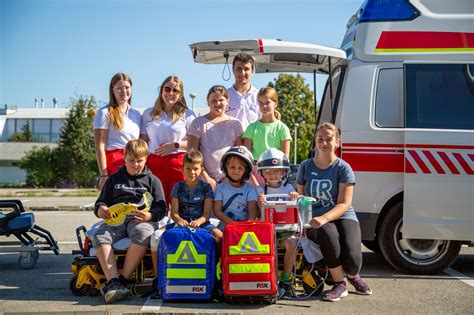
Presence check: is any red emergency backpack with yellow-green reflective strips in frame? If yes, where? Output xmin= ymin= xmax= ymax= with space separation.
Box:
xmin=222 ymin=221 xmax=277 ymax=303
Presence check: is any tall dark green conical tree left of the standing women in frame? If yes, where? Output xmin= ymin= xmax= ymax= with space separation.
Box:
xmin=58 ymin=96 xmax=97 ymax=187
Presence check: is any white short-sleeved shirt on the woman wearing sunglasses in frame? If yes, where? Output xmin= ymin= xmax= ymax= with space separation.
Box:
xmin=140 ymin=107 xmax=196 ymax=154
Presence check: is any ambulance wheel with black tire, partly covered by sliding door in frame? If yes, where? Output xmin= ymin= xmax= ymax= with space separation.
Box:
xmin=378 ymin=201 xmax=462 ymax=275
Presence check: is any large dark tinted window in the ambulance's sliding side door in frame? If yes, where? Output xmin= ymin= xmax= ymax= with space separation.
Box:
xmin=405 ymin=64 xmax=474 ymax=129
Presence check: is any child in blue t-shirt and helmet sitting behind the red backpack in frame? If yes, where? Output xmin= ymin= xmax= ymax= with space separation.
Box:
xmin=214 ymin=146 xmax=257 ymax=230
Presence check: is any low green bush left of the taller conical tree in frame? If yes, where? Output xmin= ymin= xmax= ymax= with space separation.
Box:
xmin=18 ymin=146 xmax=58 ymax=187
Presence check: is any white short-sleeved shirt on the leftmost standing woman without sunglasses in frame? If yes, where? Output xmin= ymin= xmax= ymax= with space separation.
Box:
xmin=94 ymin=105 xmax=142 ymax=151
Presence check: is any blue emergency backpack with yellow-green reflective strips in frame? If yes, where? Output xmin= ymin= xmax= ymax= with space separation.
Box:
xmin=158 ymin=227 xmax=216 ymax=300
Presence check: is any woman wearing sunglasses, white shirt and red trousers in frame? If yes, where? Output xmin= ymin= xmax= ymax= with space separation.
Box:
xmin=140 ymin=76 xmax=196 ymax=205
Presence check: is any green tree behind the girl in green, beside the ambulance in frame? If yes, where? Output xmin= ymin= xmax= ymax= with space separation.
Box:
xmin=268 ymin=74 xmax=317 ymax=163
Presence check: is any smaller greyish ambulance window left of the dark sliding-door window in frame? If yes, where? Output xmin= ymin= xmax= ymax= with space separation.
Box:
xmin=375 ymin=68 xmax=403 ymax=128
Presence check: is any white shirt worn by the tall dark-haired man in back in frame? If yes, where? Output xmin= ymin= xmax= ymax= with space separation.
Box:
xmin=225 ymin=85 xmax=260 ymax=130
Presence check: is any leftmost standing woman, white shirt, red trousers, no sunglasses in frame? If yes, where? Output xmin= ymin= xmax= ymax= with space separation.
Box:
xmin=94 ymin=73 xmax=141 ymax=189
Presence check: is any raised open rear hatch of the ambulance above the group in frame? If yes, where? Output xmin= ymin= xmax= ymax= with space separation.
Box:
xmin=189 ymin=39 xmax=347 ymax=74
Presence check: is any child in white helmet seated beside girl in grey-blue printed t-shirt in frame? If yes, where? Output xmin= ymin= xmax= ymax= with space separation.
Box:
xmin=257 ymin=148 xmax=298 ymax=299
